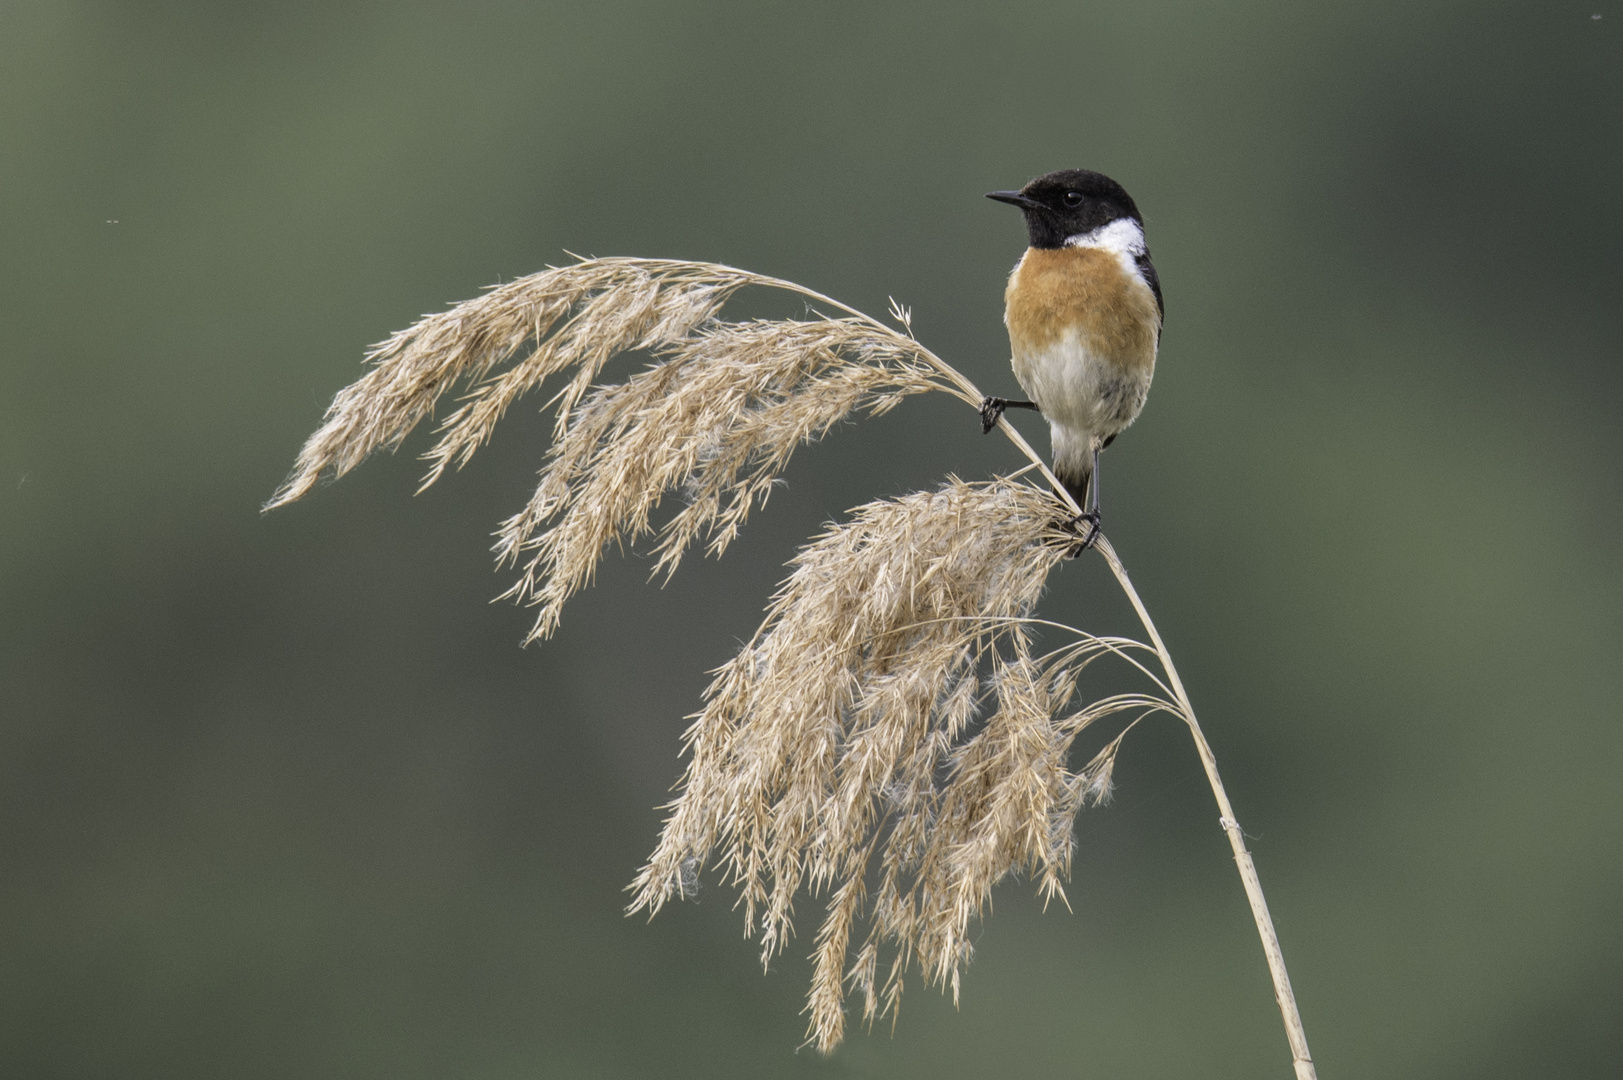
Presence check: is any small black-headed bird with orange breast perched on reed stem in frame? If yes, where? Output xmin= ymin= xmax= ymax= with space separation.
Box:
xmin=980 ymin=169 xmax=1167 ymax=554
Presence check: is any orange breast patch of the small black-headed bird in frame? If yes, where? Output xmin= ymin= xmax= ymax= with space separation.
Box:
xmin=1003 ymin=247 xmax=1160 ymax=375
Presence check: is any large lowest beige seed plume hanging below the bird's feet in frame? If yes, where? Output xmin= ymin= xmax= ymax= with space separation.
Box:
xmin=631 ymin=481 xmax=1177 ymax=1051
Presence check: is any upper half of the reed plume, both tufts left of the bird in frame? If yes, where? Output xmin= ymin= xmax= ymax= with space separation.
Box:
xmin=266 ymin=258 xmax=969 ymax=638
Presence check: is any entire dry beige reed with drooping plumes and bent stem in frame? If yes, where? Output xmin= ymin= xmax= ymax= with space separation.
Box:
xmin=266 ymin=258 xmax=1315 ymax=1080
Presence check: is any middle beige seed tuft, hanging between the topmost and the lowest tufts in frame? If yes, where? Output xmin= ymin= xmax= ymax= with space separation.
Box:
xmin=497 ymin=318 xmax=941 ymax=637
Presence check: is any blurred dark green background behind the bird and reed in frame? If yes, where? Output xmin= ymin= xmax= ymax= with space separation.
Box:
xmin=0 ymin=0 xmax=1623 ymax=1080
